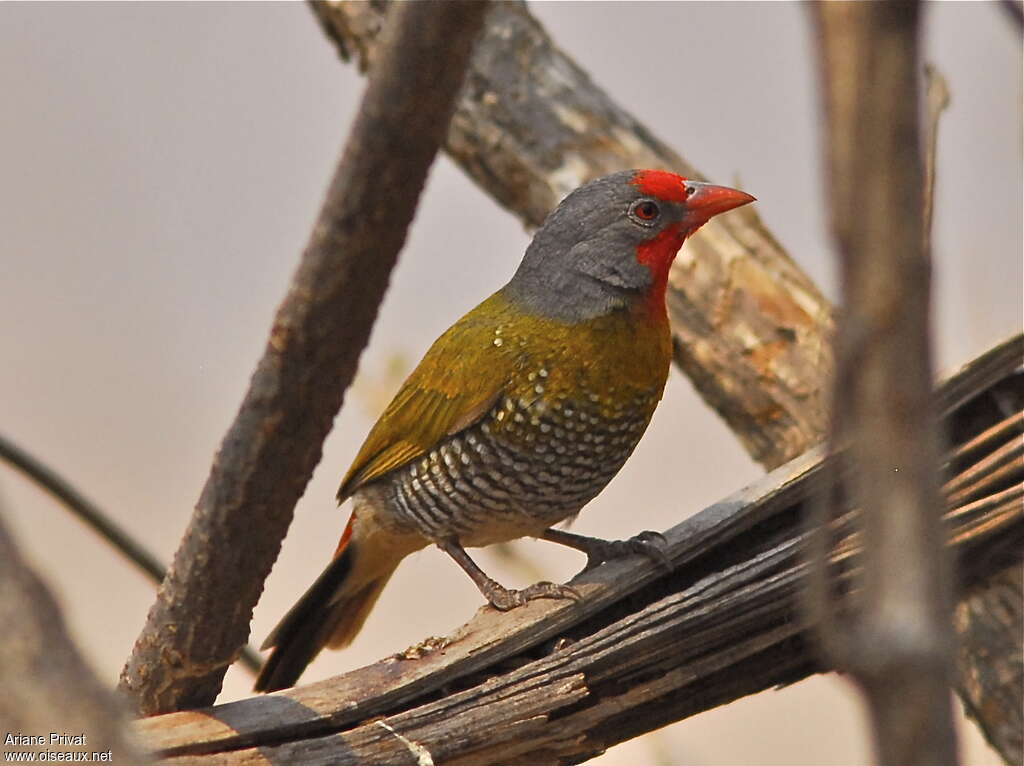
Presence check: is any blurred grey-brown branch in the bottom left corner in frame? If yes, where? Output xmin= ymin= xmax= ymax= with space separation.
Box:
xmin=0 ymin=505 xmax=147 ymax=764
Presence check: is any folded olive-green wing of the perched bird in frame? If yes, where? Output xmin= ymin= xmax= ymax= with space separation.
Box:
xmin=338 ymin=299 xmax=516 ymax=502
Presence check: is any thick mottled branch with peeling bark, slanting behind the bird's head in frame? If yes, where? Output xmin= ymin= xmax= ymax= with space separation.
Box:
xmin=312 ymin=0 xmax=831 ymax=468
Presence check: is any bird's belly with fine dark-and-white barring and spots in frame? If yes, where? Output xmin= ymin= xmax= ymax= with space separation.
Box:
xmin=372 ymin=367 xmax=662 ymax=546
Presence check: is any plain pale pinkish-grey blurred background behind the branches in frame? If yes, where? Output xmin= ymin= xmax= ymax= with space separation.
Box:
xmin=0 ymin=2 xmax=1022 ymax=766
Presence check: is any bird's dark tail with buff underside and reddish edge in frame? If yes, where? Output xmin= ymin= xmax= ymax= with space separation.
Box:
xmin=254 ymin=513 xmax=408 ymax=691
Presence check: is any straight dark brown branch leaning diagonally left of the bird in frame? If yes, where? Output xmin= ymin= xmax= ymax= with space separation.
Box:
xmin=121 ymin=2 xmax=486 ymax=713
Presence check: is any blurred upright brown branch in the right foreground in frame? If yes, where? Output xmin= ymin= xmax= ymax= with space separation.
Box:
xmin=815 ymin=2 xmax=957 ymax=766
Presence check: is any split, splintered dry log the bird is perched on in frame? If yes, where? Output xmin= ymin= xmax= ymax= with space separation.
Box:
xmin=137 ymin=337 xmax=1024 ymax=766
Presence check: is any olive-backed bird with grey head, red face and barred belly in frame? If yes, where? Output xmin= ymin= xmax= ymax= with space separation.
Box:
xmin=255 ymin=169 xmax=755 ymax=691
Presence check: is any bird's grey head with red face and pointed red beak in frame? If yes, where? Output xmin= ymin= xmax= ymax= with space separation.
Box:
xmin=504 ymin=170 xmax=754 ymax=323
